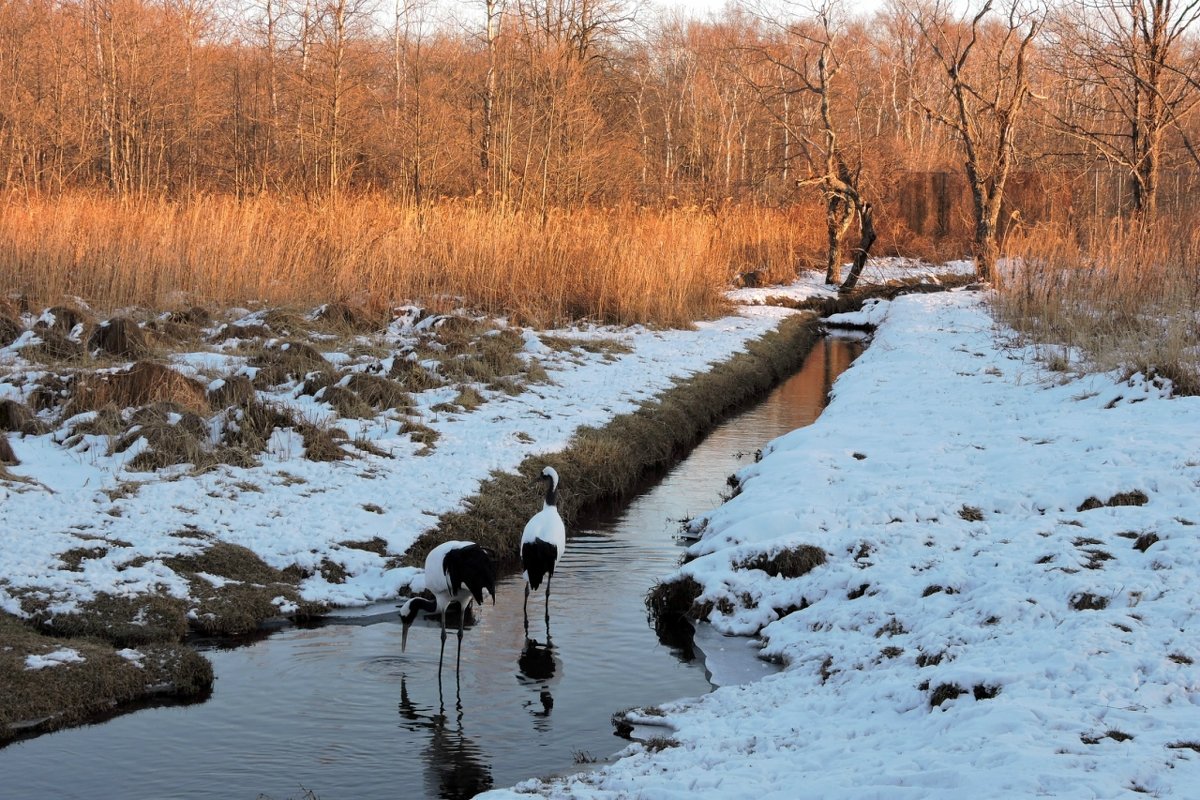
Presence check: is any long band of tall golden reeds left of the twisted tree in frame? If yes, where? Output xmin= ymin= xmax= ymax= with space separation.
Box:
xmin=0 ymin=194 xmax=820 ymax=330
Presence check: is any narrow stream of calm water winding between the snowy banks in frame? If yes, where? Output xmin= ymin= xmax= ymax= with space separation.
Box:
xmin=0 ymin=338 xmax=862 ymax=800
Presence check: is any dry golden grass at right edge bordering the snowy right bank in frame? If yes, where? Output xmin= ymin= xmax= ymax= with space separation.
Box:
xmin=998 ymin=221 xmax=1200 ymax=395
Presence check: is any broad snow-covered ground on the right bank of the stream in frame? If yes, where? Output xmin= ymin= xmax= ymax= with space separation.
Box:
xmin=484 ymin=286 xmax=1200 ymax=800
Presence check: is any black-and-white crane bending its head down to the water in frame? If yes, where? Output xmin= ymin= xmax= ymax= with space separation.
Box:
xmin=400 ymin=542 xmax=496 ymax=673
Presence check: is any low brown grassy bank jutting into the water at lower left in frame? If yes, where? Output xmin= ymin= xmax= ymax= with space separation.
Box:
xmin=0 ymin=614 xmax=212 ymax=742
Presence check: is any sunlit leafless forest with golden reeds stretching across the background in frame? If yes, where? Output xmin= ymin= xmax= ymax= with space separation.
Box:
xmin=0 ymin=0 xmax=1200 ymax=338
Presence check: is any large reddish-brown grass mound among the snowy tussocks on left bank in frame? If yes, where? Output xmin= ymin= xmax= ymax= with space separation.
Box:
xmin=67 ymin=361 xmax=210 ymax=414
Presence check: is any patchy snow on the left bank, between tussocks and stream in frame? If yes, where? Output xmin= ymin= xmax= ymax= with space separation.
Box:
xmin=0 ymin=298 xmax=794 ymax=614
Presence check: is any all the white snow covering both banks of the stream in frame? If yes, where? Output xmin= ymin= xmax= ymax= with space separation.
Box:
xmin=0 ymin=265 xmax=1200 ymax=800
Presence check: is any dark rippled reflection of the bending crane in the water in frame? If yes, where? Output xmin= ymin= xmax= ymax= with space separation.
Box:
xmin=400 ymin=675 xmax=492 ymax=800
